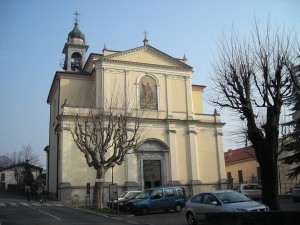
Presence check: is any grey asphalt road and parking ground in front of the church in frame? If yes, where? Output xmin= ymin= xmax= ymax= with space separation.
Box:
xmin=0 ymin=192 xmax=300 ymax=225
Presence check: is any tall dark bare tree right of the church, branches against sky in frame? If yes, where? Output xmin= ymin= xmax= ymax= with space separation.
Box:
xmin=211 ymin=21 xmax=299 ymax=209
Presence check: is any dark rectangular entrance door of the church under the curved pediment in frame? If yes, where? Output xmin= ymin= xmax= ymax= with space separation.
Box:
xmin=143 ymin=160 xmax=161 ymax=189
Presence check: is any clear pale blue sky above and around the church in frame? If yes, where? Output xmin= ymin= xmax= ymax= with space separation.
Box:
xmin=0 ymin=0 xmax=300 ymax=167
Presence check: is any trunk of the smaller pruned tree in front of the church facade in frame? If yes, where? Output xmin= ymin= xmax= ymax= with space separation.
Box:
xmin=93 ymin=167 xmax=105 ymax=209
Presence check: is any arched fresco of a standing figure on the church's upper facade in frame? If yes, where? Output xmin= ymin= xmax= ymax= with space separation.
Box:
xmin=140 ymin=76 xmax=158 ymax=110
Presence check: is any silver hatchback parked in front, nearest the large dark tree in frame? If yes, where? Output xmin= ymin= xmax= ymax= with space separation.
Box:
xmin=186 ymin=191 xmax=269 ymax=225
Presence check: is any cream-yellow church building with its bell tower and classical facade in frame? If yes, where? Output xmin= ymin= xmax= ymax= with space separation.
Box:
xmin=46 ymin=16 xmax=227 ymax=201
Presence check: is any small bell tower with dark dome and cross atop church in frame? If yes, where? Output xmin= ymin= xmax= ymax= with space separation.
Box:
xmin=61 ymin=11 xmax=89 ymax=71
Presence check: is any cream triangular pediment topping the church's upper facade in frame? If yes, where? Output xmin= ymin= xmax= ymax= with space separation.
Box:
xmin=102 ymin=45 xmax=192 ymax=70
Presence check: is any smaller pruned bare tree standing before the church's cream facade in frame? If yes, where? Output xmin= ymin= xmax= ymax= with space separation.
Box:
xmin=70 ymin=90 xmax=143 ymax=208
